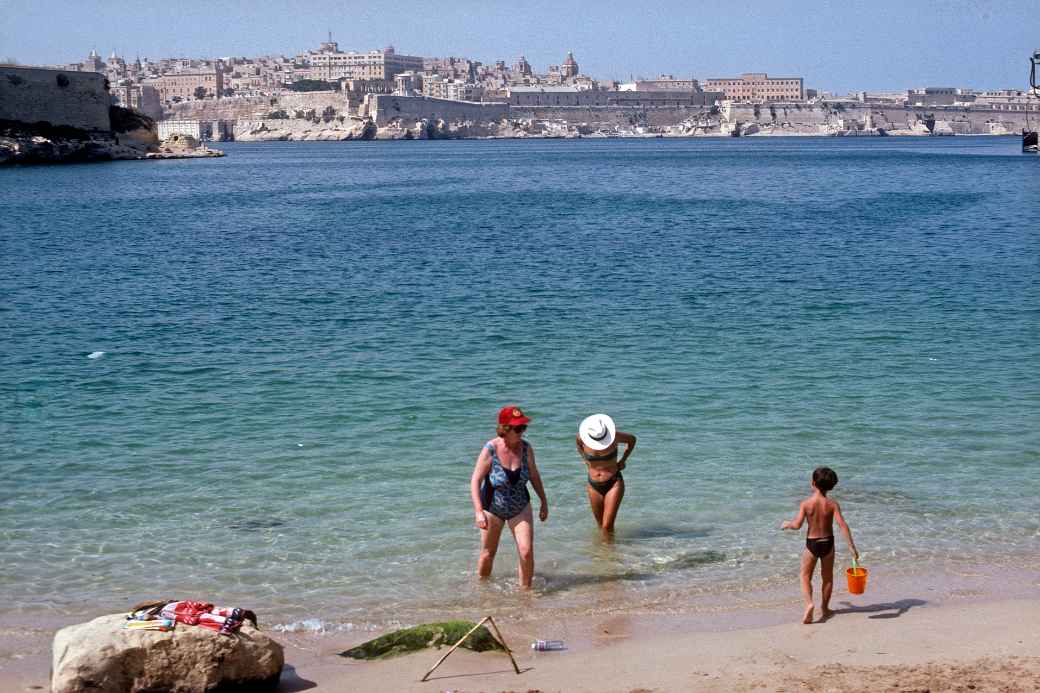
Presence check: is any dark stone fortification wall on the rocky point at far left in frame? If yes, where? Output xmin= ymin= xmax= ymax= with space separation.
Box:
xmin=0 ymin=66 xmax=111 ymax=130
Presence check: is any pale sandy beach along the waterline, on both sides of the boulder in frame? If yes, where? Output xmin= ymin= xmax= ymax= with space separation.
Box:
xmin=0 ymin=573 xmax=1040 ymax=693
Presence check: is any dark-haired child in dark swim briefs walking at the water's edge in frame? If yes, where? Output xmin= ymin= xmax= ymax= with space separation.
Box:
xmin=780 ymin=467 xmax=859 ymax=623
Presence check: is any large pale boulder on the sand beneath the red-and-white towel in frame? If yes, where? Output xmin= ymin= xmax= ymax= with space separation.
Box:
xmin=51 ymin=614 xmax=285 ymax=693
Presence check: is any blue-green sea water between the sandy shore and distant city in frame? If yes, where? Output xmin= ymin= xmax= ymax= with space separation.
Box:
xmin=0 ymin=137 xmax=1040 ymax=626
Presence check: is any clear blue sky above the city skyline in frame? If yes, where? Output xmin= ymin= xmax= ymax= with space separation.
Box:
xmin=0 ymin=0 xmax=1040 ymax=94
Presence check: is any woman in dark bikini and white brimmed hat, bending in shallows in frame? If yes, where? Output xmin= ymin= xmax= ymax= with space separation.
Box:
xmin=575 ymin=414 xmax=635 ymax=534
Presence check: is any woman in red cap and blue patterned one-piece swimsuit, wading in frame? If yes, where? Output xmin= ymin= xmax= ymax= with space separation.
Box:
xmin=469 ymin=405 xmax=549 ymax=589
